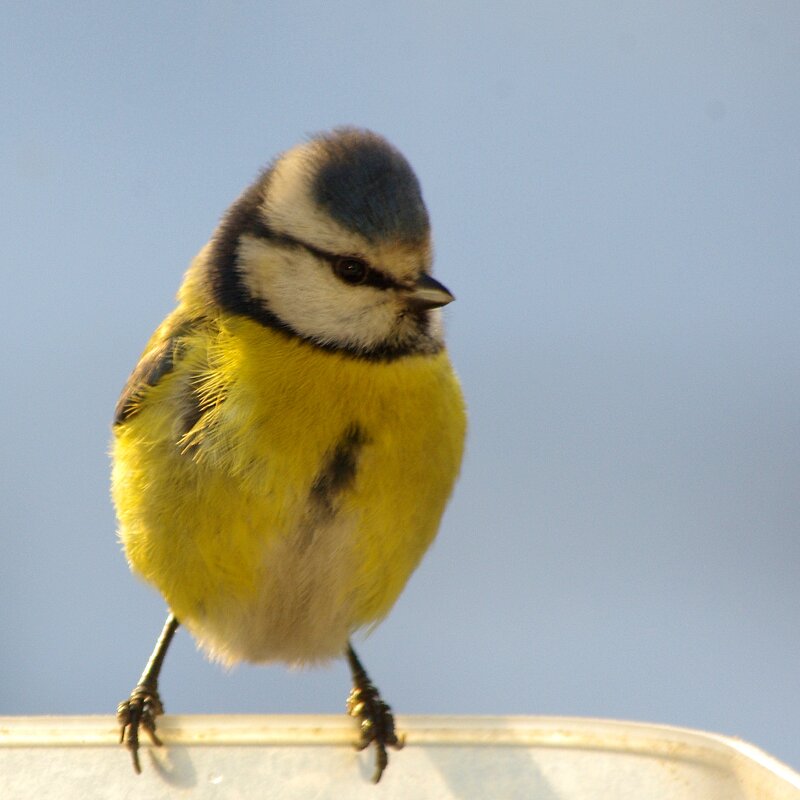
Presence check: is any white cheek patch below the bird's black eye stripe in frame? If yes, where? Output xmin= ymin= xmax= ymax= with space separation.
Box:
xmin=239 ymin=237 xmax=401 ymax=348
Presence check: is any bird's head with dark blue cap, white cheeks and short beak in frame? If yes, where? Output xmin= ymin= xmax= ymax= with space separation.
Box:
xmin=207 ymin=128 xmax=453 ymax=358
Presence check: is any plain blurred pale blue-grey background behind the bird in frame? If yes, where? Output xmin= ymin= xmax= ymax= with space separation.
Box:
xmin=0 ymin=0 xmax=800 ymax=768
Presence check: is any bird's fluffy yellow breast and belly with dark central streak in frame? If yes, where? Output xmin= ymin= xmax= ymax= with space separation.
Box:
xmin=113 ymin=317 xmax=465 ymax=661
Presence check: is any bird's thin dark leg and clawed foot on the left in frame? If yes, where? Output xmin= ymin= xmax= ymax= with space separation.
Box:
xmin=117 ymin=613 xmax=180 ymax=774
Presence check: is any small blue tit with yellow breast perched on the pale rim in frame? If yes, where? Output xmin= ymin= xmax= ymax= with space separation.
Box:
xmin=111 ymin=127 xmax=467 ymax=782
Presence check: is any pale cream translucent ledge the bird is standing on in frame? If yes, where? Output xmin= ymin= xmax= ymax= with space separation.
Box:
xmin=0 ymin=715 xmax=800 ymax=800
